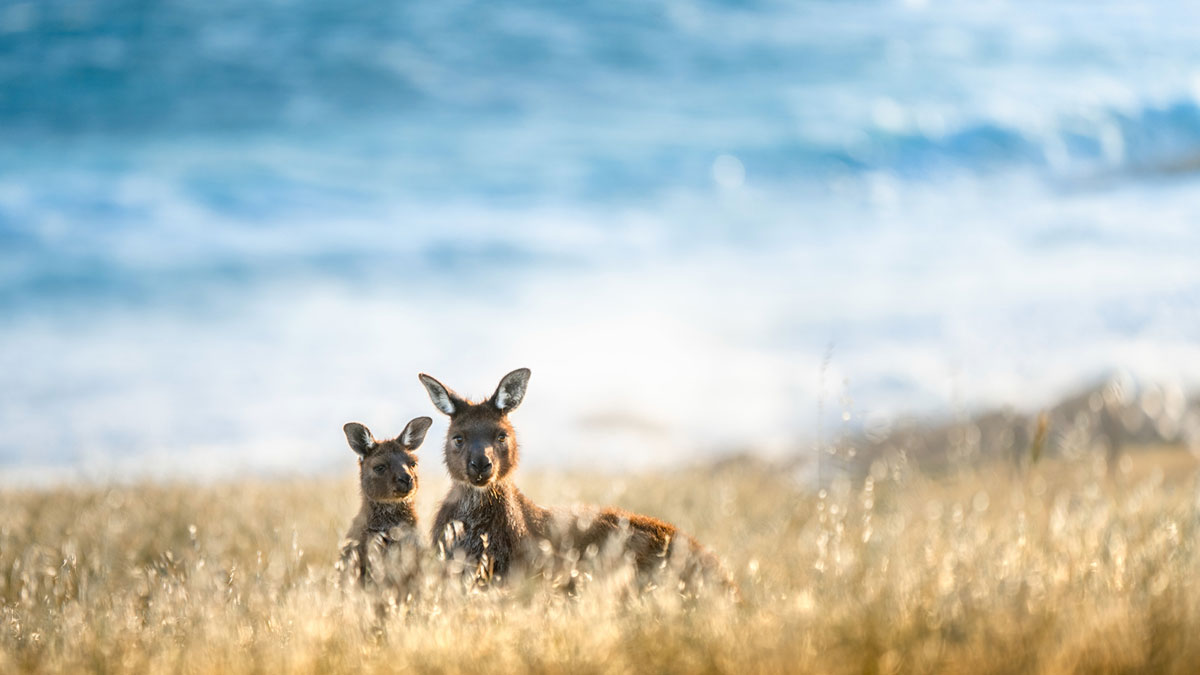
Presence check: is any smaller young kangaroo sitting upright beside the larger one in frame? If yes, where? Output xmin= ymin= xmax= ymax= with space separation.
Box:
xmin=338 ymin=417 xmax=433 ymax=583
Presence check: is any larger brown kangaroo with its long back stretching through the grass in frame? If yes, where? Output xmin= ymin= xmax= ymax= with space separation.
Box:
xmin=420 ymin=368 xmax=737 ymax=597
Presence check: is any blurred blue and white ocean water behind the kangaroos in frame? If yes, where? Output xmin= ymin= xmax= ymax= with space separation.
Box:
xmin=0 ymin=0 xmax=1200 ymax=479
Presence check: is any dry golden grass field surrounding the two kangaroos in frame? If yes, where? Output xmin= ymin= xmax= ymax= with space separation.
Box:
xmin=0 ymin=450 xmax=1200 ymax=674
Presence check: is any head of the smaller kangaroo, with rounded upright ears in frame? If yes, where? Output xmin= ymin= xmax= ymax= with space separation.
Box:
xmin=342 ymin=417 xmax=433 ymax=503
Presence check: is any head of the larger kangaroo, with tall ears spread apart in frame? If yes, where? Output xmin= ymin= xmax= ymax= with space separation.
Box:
xmin=420 ymin=368 xmax=529 ymax=488
